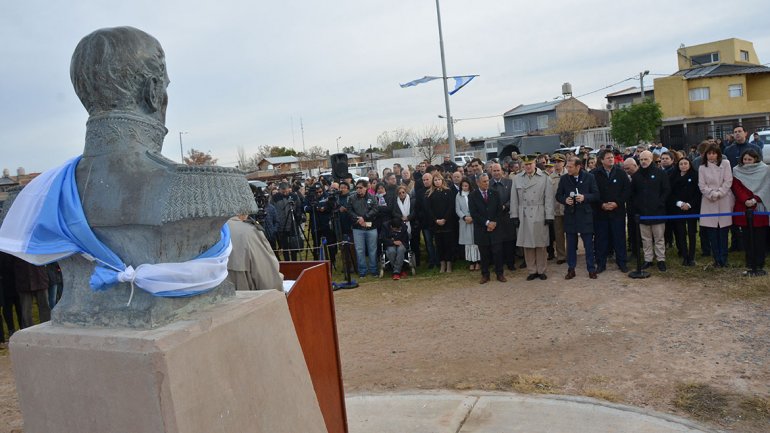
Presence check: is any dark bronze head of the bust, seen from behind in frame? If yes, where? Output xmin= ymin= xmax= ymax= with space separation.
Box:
xmin=70 ymin=27 xmax=170 ymax=123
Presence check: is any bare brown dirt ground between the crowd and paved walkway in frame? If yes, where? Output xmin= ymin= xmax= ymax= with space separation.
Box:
xmin=0 ymin=257 xmax=770 ymax=433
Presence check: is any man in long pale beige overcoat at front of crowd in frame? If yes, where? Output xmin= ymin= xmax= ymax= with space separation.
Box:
xmin=511 ymin=155 xmax=555 ymax=281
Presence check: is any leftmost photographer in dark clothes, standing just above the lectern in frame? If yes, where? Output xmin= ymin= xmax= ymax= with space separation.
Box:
xmin=273 ymin=182 xmax=304 ymax=261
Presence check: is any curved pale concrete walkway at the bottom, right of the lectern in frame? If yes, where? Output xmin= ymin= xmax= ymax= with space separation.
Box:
xmin=346 ymin=392 xmax=717 ymax=433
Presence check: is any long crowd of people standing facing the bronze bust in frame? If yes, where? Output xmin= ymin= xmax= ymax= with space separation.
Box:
xmin=264 ymin=125 xmax=770 ymax=284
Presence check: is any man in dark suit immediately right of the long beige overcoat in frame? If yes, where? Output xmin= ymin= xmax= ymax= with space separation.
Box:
xmin=556 ymin=156 xmax=600 ymax=280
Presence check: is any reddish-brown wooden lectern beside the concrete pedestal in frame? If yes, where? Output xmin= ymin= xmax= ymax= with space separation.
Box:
xmin=280 ymin=262 xmax=348 ymax=433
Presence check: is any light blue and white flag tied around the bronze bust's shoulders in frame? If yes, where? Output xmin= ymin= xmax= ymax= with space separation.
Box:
xmin=0 ymin=156 xmax=232 ymax=297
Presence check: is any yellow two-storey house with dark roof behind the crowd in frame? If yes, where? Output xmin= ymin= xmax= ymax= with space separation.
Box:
xmin=654 ymin=38 xmax=770 ymax=149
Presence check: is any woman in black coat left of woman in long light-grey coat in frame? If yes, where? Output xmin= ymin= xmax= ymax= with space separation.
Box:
xmin=425 ymin=173 xmax=457 ymax=272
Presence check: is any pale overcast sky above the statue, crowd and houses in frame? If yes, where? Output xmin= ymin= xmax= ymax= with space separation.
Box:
xmin=0 ymin=0 xmax=770 ymax=174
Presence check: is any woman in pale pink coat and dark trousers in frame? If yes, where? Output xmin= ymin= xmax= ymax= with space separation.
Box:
xmin=698 ymin=144 xmax=735 ymax=268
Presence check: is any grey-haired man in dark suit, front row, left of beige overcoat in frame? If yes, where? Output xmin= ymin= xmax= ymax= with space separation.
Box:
xmin=468 ymin=173 xmax=508 ymax=284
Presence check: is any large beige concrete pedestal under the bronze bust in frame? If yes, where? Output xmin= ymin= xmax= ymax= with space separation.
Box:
xmin=10 ymin=291 xmax=326 ymax=433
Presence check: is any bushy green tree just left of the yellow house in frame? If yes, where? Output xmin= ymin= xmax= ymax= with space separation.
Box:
xmin=611 ymin=99 xmax=663 ymax=146
